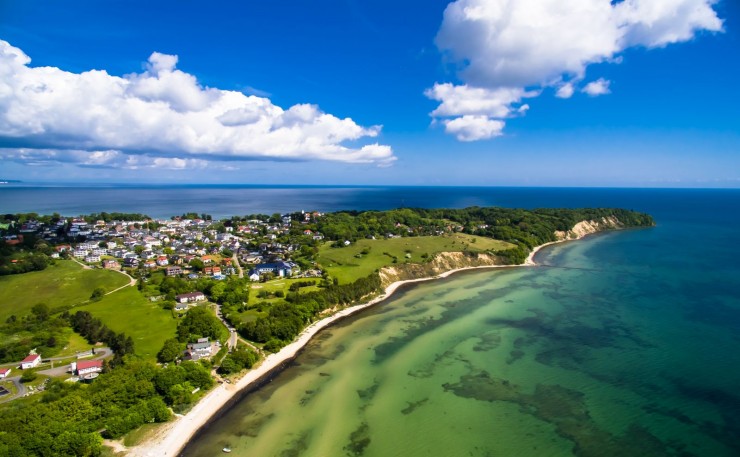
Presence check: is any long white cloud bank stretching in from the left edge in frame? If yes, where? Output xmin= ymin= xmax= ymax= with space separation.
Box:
xmin=0 ymin=40 xmax=395 ymax=169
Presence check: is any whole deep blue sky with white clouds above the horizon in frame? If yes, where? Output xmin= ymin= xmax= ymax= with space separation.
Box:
xmin=0 ymin=0 xmax=740 ymax=187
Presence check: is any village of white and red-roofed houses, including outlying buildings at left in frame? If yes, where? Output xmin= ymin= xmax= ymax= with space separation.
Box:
xmin=0 ymin=212 xmax=330 ymax=401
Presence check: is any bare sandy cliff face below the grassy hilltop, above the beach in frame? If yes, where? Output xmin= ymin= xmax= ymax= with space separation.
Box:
xmin=379 ymin=252 xmax=503 ymax=287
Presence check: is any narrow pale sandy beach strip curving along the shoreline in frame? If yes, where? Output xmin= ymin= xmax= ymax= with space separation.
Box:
xmin=129 ymin=236 xmax=572 ymax=457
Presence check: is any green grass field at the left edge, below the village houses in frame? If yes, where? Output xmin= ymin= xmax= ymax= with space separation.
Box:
xmin=0 ymin=260 xmax=129 ymax=322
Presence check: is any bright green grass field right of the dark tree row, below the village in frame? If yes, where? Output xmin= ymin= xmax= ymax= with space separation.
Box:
xmin=75 ymin=287 xmax=177 ymax=360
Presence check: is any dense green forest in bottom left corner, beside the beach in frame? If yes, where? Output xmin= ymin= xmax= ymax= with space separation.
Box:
xmin=0 ymin=357 xmax=213 ymax=457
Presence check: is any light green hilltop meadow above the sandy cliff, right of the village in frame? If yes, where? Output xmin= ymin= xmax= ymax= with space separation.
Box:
xmin=318 ymin=233 xmax=514 ymax=284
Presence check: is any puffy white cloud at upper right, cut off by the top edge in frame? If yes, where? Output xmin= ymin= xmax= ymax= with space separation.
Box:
xmin=425 ymin=0 xmax=722 ymax=141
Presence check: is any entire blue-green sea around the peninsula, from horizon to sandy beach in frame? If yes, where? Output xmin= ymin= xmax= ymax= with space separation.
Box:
xmin=0 ymin=186 xmax=740 ymax=457
